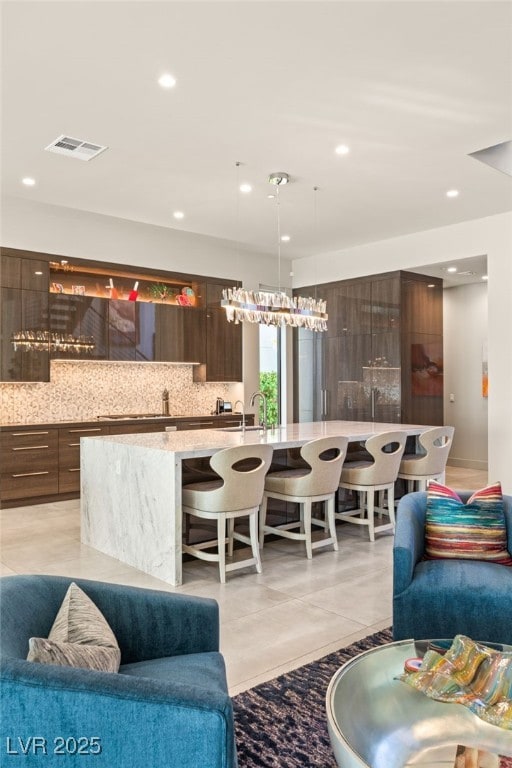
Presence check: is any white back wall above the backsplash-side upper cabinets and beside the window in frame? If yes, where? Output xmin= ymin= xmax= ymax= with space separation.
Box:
xmin=1 ymin=197 xmax=291 ymax=397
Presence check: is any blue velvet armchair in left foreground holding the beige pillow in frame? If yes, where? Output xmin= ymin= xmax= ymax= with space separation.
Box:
xmin=0 ymin=576 xmax=237 ymax=768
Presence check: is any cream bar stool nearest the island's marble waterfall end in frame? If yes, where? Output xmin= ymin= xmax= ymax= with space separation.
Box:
xmin=182 ymin=445 xmax=272 ymax=584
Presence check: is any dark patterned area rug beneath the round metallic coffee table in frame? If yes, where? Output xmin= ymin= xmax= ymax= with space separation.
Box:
xmin=233 ymin=629 xmax=393 ymax=768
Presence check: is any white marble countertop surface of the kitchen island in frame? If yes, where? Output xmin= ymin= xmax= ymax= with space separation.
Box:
xmin=83 ymin=421 xmax=427 ymax=459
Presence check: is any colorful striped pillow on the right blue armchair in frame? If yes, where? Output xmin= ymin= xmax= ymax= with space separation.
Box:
xmin=425 ymin=481 xmax=512 ymax=566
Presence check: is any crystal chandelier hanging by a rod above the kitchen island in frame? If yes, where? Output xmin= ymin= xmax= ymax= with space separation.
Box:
xmin=221 ymin=171 xmax=328 ymax=331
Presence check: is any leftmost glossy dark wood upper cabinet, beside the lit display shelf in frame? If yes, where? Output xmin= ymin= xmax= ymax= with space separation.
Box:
xmin=0 ymin=254 xmax=50 ymax=381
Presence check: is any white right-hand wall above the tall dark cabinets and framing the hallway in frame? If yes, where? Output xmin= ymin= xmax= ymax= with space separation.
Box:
xmin=292 ymin=212 xmax=512 ymax=494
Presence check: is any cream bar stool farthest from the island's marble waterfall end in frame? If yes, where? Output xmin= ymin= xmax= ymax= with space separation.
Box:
xmin=398 ymin=427 xmax=455 ymax=493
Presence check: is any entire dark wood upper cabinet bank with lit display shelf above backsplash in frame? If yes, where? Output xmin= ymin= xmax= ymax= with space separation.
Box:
xmin=0 ymin=248 xmax=242 ymax=382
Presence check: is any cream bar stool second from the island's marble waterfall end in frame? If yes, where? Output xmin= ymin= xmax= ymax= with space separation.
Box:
xmin=260 ymin=437 xmax=348 ymax=560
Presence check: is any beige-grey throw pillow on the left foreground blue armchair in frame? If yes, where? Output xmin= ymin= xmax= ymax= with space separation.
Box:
xmin=27 ymin=582 xmax=121 ymax=672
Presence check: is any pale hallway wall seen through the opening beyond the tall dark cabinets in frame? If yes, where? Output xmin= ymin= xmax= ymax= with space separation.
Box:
xmin=443 ymin=283 xmax=488 ymax=468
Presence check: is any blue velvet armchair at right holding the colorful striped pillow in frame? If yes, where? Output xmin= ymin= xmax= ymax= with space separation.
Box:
xmin=393 ymin=491 xmax=512 ymax=645
